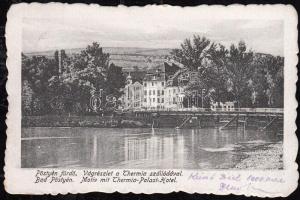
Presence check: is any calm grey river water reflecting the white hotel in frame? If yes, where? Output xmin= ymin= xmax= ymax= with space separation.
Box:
xmin=21 ymin=127 xmax=282 ymax=169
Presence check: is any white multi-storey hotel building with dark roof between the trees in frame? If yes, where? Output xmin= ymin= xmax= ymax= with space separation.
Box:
xmin=121 ymin=64 xmax=184 ymax=110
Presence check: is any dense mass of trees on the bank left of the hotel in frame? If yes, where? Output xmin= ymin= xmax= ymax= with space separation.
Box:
xmin=22 ymin=43 xmax=125 ymax=115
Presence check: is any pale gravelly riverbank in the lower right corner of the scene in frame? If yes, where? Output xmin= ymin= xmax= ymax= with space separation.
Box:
xmin=234 ymin=142 xmax=283 ymax=170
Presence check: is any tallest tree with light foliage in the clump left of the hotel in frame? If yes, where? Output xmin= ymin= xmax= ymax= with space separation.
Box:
xmin=50 ymin=42 xmax=109 ymax=113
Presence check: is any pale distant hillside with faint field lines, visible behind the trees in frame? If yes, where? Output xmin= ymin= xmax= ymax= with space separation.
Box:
xmin=24 ymin=47 xmax=171 ymax=71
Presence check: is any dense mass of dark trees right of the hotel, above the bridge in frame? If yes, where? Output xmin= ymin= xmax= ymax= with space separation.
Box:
xmin=171 ymin=36 xmax=284 ymax=107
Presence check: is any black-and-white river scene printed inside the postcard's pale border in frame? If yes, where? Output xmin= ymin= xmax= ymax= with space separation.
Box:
xmin=21 ymin=9 xmax=285 ymax=170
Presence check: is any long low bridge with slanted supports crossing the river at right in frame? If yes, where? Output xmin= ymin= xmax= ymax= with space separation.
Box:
xmin=133 ymin=108 xmax=284 ymax=130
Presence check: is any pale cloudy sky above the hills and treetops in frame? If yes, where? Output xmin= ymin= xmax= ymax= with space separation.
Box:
xmin=22 ymin=13 xmax=284 ymax=56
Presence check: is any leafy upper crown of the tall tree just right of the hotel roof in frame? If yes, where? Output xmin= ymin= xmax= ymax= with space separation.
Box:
xmin=171 ymin=35 xmax=210 ymax=73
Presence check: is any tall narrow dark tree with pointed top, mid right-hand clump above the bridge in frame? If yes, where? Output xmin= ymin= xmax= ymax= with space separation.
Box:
xmin=226 ymin=41 xmax=254 ymax=107
